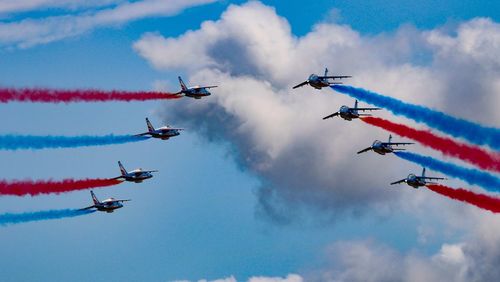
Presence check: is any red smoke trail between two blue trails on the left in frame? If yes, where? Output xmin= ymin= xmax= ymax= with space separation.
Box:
xmin=0 ymin=179 xmax=121 ymax=196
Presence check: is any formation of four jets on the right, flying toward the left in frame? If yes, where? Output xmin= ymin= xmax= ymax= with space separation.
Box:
xmin=292 ymin=68 xmax=445 ymax=188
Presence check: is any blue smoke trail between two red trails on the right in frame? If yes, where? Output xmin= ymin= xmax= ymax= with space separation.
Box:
xmin=394 ymin=152 xmax=500 ymax=189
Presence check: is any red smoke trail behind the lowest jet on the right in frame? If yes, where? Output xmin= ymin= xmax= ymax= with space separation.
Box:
xmin=427 ymin=185 xmax=500 ymax=213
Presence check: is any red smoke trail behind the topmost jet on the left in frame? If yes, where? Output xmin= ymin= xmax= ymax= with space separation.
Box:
xmin=0 ymin=88 xmax=181 ymax=103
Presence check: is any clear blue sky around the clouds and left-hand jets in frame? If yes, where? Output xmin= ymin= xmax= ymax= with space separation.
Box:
xmin=0 ymin=0 xmax=500 ymax=281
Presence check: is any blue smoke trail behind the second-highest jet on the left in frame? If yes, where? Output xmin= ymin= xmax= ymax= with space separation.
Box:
xmin=0 ymin=134 xmax=149 ymax=150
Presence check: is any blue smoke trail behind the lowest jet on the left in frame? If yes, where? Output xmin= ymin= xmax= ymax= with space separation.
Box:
xmin=0 ymin=209 xmax=95 ymax=226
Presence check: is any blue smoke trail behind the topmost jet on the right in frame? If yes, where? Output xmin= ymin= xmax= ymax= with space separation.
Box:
xmin=331 ymin=85 xmax=500 ymax=150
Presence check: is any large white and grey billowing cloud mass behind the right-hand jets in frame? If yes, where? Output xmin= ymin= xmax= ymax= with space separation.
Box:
xmin=134 ymin=2 xmax=500 ymax=281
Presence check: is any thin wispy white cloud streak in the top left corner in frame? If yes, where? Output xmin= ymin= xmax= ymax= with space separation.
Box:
xmin=0 ymin=0 xmax=215 ymax=48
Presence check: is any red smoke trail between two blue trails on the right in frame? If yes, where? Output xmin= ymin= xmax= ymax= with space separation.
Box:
xmin=361 ymin=117 xmax=500 ymax=172
